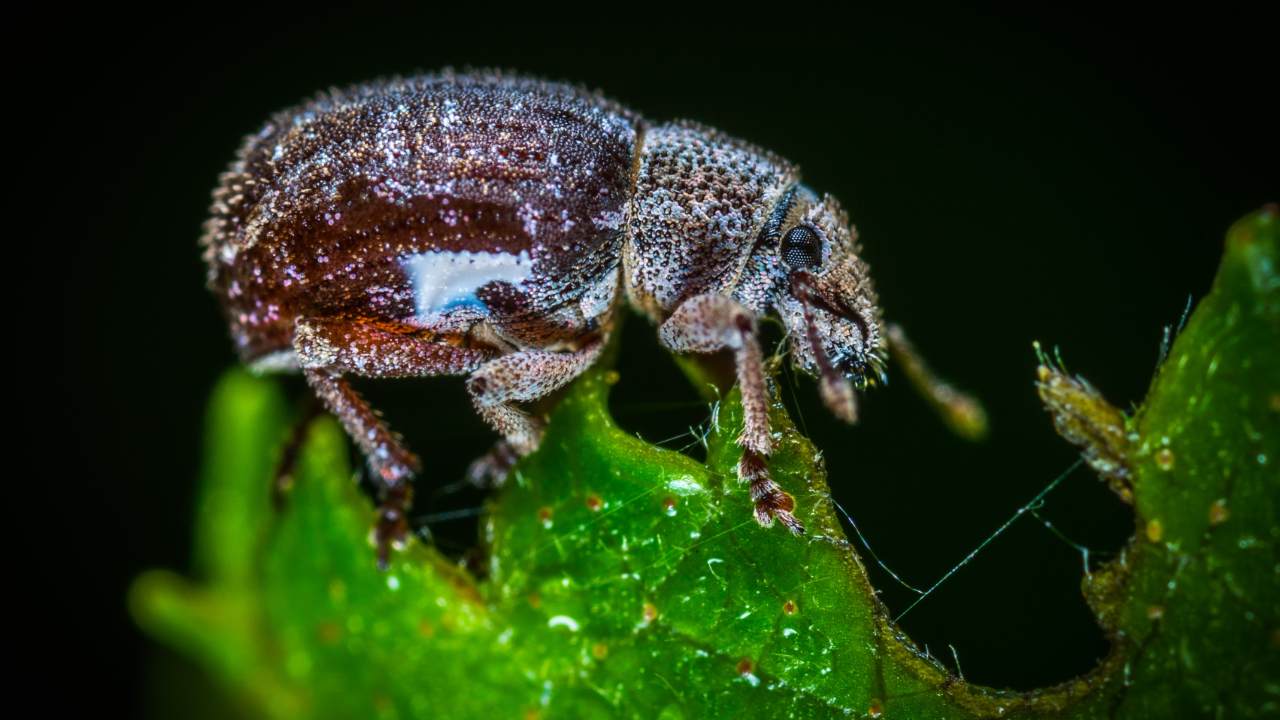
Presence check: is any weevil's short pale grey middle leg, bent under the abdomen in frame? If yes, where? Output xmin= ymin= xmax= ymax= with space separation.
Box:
xmin=467 ymin=334 xmax=605 ymax=461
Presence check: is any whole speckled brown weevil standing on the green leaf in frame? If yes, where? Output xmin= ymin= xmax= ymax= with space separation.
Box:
xmin=202 ymin=72 xmax=977 ymax=566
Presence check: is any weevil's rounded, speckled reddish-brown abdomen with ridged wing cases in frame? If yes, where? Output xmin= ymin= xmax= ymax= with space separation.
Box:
xmin=205 ymin=74 xmax=639 ymax=359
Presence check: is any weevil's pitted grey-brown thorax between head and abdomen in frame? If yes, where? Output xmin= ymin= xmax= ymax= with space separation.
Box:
xmin=623 ymin=122 xmax=797 ymax=320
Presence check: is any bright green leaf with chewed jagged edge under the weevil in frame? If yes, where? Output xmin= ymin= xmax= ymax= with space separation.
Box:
xmin=131 ymin=209 xmax=1280 ymax=719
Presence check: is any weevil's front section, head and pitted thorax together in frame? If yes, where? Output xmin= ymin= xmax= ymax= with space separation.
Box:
xmin=623 ymin=123 xmax=884 ymax=421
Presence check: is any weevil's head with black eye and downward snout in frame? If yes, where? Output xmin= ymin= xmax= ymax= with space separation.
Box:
xmin=765 ymin=186 xmax=884 ymax=423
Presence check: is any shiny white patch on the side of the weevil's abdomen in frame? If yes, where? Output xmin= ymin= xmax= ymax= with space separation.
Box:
xmin=401 ymin=250 xmax=532 ymax=319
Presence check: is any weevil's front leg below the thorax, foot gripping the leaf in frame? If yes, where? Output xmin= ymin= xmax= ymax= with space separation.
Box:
xmin=658 ymin=295 xmax=804 ymax=534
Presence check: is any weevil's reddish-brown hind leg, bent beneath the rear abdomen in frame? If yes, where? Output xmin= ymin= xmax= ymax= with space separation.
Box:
xmin=293 ymin=318 xmax=494 ymax=568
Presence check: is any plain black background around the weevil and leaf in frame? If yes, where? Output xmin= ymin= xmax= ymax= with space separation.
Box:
xmin=57 ymin=8 xmax=1280 ymax=712
